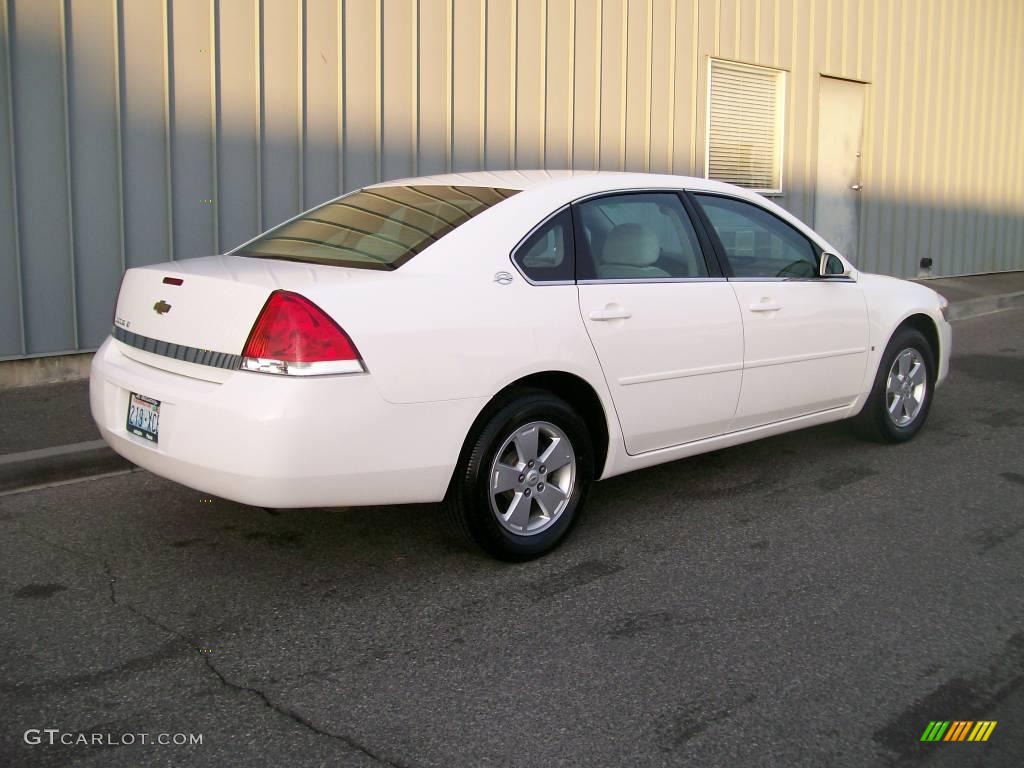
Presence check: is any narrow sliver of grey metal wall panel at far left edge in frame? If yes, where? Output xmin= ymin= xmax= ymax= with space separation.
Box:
xmin=0 ymin=1 xmax=26 ymax=357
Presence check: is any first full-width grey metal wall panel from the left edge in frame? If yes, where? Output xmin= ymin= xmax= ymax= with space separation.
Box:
xmin=10 ymin=0 xmax=78 ymax=353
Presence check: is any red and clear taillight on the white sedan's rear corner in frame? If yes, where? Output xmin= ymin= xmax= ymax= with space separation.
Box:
xmin=242 ymin=291 xmax=366 ymax=376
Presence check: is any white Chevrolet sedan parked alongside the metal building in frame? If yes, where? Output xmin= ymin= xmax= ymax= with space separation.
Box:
xmin=90 ymin=171 xmax=951 ymax=559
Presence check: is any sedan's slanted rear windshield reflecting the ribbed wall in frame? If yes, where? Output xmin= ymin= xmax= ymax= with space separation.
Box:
xmin=233 ymin=185 xmax=518 ymax=269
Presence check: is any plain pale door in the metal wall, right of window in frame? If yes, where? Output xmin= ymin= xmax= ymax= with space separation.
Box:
xmin=814 ymin=77 xmax=864 ymax=260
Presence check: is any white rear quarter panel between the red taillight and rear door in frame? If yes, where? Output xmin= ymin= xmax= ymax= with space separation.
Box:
xmin=292 ymin=186 xmax=614 ymax=402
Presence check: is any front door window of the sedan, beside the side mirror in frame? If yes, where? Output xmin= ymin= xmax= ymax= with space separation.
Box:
xmin=693 ymin=195 xmax=818 ymax=280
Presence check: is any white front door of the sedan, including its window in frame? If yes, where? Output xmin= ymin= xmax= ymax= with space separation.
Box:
xmin=690 ymin=193 xmax=868 ymax=431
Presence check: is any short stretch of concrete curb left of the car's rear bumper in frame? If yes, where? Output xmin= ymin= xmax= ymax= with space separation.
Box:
xmin=0 ymin=440 xmax=132 ymax=494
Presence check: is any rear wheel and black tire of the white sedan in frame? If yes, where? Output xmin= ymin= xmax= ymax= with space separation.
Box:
xmin=443 ymin=389 xmax=594 ymax=561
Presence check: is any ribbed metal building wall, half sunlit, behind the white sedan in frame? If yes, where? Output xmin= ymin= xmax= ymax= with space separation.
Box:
xmin=0 ymin=0 xmax=1024 ymax=358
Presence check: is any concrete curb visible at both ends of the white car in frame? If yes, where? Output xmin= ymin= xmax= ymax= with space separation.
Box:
xmin=0 ymin=291 xmax=1024 ymax=494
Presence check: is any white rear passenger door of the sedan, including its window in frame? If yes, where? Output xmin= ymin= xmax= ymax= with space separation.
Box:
xmin=572 ymin=190 xmax=743 ymax=455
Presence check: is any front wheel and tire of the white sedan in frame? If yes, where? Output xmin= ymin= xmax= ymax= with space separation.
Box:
xmin=855 ymin=328 xmax=937 ymax=443
